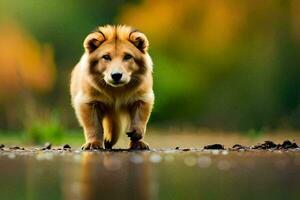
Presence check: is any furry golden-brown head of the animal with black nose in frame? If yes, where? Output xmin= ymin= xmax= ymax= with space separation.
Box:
xmin=83 ymin=25 xmax=152 ymax=87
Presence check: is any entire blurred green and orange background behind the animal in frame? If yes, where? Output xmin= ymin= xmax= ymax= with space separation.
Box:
xmin=0 ymin=0 xmax=300 ymax=143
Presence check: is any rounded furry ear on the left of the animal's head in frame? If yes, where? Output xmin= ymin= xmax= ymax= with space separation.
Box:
xmin=83 ymin=31 xmax=105 ymax=53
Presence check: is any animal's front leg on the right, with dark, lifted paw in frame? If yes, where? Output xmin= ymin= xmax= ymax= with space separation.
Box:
xmin=127 ymin=101 xmax=152 ymax=150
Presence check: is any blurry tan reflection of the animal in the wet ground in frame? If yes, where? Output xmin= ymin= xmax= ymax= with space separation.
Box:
xmin=64 ymin=152 xmax=151 ymax=200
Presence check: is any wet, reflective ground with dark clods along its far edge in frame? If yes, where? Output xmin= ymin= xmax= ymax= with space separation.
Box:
xmin=0 ymin=141 xmax=300 ymax=200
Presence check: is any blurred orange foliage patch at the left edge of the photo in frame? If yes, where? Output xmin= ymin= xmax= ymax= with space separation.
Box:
xmin=0 ymin=21 xmax=55 ymax=103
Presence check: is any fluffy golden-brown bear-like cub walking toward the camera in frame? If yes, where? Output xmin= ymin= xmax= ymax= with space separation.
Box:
xmin=70 ymin=25 xmax=154 ymax=150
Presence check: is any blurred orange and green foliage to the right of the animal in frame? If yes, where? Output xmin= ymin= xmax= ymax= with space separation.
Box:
xmin=118 ymin=0 xmax=300 ymax=129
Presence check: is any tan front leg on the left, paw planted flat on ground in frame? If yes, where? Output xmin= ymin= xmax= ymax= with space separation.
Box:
xmin=75 ymin=103 xmax=103 ymax=150
